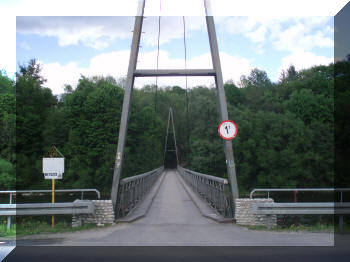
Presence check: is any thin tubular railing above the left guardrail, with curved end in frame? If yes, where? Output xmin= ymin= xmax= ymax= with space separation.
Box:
xmin=0 ymin=188 xmax=101 ymax=229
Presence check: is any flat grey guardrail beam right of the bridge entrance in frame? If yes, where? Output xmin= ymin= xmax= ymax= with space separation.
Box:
xmin=253 ymin=202 xmax=350 ymax=215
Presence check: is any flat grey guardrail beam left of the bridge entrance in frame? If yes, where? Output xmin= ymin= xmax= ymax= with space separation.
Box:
xmin=0 ymin=200 xmax=94 ymax=216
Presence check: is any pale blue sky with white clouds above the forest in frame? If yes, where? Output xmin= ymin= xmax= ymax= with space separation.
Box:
xmin=0 ymin=0 xmax=344 ymax=94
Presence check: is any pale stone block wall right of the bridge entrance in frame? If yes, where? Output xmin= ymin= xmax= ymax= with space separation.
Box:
xmin=235 ymin=198 xmax=277 ymax=228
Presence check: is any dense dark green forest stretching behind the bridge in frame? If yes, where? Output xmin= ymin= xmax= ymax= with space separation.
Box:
xmin=0 ymin=60 xmax=350 ymax=193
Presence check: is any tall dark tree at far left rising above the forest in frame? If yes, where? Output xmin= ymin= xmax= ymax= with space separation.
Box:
xmin=16 ymin=60 xmax=57 ymax=188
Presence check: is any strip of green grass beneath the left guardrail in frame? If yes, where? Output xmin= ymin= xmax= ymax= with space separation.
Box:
xmin=0 ymin=221 xmax=112 ymax=238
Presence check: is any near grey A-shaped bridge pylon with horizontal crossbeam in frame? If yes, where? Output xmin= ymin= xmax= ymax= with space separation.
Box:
xmin=111 ymin=0 xmax=238 ymax=213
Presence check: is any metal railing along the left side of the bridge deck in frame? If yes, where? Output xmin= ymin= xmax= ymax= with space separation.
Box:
xmin=115 ymin=166 xmax=164 ymax=218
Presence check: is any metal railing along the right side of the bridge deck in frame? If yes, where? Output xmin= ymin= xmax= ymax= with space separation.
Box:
xmin=177 ymin=166 xmax=234 ymax=217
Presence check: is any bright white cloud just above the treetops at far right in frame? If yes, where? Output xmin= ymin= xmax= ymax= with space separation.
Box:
xmin=278 ymin=51 xmax=333 ymax=75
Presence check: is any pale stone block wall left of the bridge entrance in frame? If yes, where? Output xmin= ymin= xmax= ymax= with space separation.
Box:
xmin=72 ymin=200 xmax=114 ymax=227
